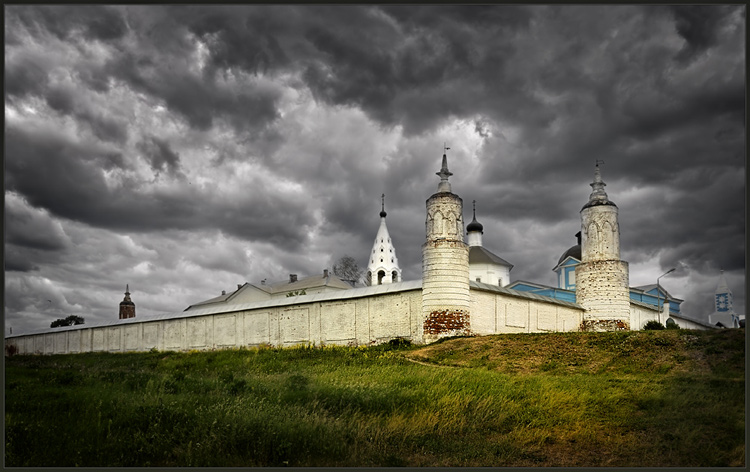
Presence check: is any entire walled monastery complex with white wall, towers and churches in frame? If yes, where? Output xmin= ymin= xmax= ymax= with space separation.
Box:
xmin=5 ymin=154 xmax=734 ymax=354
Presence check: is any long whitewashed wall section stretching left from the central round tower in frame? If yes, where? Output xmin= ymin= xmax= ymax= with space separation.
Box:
xmin=6 ymin=281 xmax=422 ymax=354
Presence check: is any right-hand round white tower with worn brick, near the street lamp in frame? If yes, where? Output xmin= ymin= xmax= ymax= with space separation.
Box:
xmin=575 ymin=161 xmax=630 ymax=331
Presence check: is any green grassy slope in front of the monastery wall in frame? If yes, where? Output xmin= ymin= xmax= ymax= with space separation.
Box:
xmin=5 ymin=330 xmax=745 ymax=467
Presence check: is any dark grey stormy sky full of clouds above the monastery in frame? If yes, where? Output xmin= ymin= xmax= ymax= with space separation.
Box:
xmin=4 ymin=5 xmax=746 ymax=333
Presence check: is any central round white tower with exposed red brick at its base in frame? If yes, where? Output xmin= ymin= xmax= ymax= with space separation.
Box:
xmin=422 ymin=148 xmax=470 ymax=342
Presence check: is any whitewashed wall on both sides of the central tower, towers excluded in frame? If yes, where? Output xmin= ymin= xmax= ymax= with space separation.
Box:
xmin=5 ymin=281 xmax=583 ymax=354
